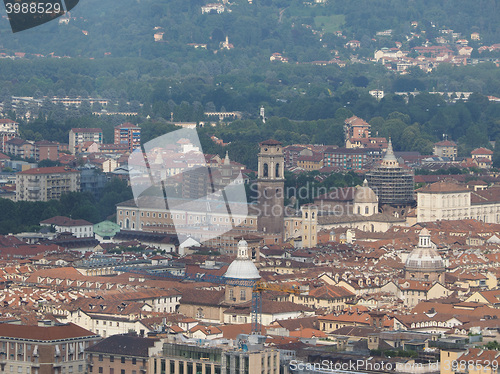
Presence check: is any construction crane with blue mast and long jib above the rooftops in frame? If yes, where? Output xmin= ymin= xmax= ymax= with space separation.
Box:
xmin=115 ymin=267 xmax=301 ymax=335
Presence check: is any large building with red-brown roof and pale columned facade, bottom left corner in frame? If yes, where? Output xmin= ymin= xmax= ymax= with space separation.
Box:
xmin=0 ymin=322 xmax=101 ymax=374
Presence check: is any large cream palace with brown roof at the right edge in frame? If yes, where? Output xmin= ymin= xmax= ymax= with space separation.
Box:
xmin=417 ymin=180 xmax=500 ymax=223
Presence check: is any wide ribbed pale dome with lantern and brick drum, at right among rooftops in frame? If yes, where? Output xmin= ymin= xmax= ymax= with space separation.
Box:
xmin=405 ymin=228 xmax=445 ymax=284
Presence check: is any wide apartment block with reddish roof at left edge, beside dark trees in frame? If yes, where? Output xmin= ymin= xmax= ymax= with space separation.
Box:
xmin=16 ymin=166 xmax=80 ymax=201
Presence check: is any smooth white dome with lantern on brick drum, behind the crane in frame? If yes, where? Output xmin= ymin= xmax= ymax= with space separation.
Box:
xmin=224 ymin=239 xmax=260 ymax=305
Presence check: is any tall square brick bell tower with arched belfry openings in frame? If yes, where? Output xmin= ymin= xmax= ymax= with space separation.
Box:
xmin=257 ymin=139 xmax=285 ymax=234
